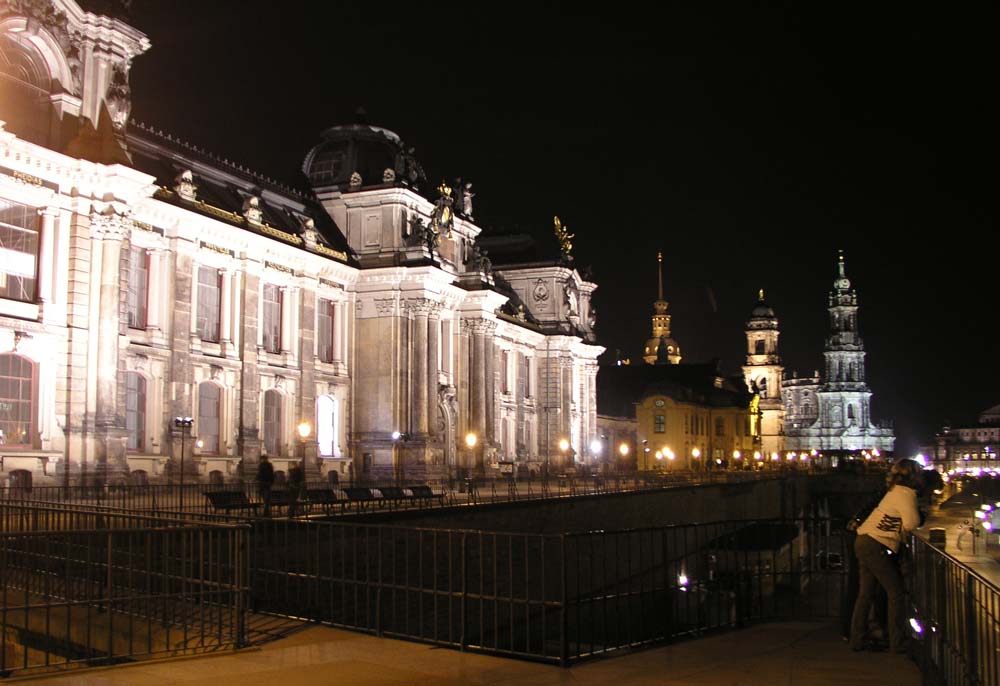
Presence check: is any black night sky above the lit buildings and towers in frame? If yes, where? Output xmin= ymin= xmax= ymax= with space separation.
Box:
xmin=131 ymin=5 xmax=1000 ymax=452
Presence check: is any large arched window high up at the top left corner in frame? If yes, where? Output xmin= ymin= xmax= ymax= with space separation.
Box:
xmin=0 ymin=32 xmax=52 ymax=145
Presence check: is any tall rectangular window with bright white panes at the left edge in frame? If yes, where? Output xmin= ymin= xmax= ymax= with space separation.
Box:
xmin=0 ymin=198 xmax=38 ymax=302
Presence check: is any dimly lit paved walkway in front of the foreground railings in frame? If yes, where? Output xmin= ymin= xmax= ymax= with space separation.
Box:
xmin=12 ymin=622 xmax=920 ymax=686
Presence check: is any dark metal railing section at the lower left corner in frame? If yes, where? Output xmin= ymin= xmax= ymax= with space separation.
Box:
xmin=0 ymin=503 xmax=250 ymax=676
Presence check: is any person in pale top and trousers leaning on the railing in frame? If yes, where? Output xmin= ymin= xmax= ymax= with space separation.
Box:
xmin=850 ymin=459 xmax=922 ymax=653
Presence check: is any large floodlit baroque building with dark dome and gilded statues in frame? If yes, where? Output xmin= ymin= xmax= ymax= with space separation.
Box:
xmin=0 ymin=0 xmax=602 ymax=492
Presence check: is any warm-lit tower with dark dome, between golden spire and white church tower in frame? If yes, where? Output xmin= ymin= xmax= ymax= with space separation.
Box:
xmin=743 ymin=289 xmax=785 ymax=454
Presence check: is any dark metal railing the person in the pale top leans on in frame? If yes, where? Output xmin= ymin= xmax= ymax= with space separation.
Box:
xmin=910 ymin=537 xmax=1000 ymax=686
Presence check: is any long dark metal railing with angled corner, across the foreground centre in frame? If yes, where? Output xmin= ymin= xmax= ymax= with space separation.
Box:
xmin=250 ymin=519 xmax=846 ymax=665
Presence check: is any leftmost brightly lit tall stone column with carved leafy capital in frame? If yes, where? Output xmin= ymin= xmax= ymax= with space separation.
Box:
xmin=90 ymin=212 xmax=130 ymax=479
